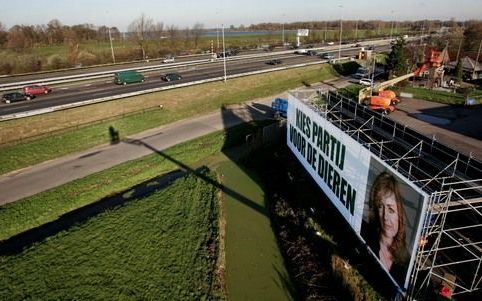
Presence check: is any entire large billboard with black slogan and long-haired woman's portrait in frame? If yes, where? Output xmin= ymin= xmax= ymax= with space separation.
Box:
xmin=287 ymin=94 xmax=428 ymax=289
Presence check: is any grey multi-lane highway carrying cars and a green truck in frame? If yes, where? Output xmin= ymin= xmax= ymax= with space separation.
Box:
xmin=0 ymin=42 xmax=394 ymax=116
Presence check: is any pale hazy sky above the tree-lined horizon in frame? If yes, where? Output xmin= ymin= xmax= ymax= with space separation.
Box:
xmin=0 ymin=0 xmax=482 ymax=31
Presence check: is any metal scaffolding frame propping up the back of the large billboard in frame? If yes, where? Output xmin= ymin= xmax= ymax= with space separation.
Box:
xmin=292 ymin=90 xmax=482 ymax=300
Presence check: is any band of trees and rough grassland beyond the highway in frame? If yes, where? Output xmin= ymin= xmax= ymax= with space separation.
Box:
xmin=0 ymin=14 xmax=482 ymax=74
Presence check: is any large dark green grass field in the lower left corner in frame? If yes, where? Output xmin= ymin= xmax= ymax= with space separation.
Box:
xmin=0 ymin=170 xmax=222 ymax=300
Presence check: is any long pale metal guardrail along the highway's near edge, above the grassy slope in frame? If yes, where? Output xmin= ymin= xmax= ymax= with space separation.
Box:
xmin=0 ymin=57 xmax=348 ymax=121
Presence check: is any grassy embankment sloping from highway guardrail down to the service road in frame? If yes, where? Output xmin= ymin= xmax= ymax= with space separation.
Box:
xmin=0 ymin=65 xmax=335 ymax=174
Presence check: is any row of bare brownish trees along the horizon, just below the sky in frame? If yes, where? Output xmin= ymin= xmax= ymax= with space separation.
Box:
xmin=0 ymin=14 xmax=480 ymax=50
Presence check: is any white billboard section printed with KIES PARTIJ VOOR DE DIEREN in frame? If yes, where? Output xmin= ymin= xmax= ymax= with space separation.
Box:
xmin=287 ymin=95 xmax=371 ymax=233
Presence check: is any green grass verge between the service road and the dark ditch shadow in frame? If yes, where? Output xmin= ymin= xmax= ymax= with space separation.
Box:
xmin=0 ymin=122 xmax=266 ymax=240
